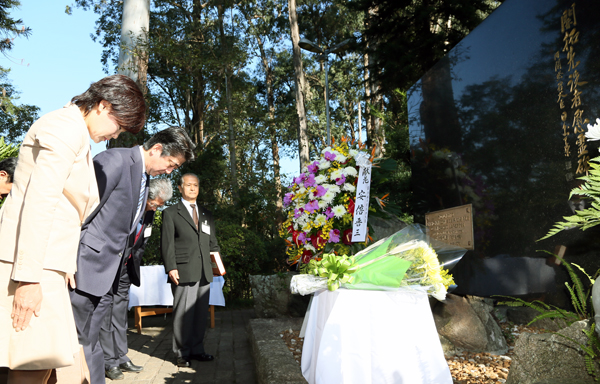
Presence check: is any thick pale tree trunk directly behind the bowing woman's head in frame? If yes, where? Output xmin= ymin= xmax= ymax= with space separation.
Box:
xmin=108 ymin=0 xmax=150 ymax=148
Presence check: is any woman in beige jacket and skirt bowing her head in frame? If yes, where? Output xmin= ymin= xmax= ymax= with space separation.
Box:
xmin=0 ymin=75 xmax=146 ymax=384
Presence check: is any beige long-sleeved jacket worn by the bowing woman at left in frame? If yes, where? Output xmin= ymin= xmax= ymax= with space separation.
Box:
xmin=0 ymin=104 xmax=99 ymax=282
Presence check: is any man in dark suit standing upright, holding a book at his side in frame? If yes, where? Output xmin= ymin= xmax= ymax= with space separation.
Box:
xmin=161 ymin=173 xmax=219 ymax=367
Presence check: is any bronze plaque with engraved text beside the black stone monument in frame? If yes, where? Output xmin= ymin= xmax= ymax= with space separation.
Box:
xmin=425 ymin=204 xmax=474 ymax=250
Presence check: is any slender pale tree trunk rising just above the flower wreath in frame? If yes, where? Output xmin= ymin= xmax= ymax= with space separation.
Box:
xmin=288 ymin=0 xmax=310 ymax=171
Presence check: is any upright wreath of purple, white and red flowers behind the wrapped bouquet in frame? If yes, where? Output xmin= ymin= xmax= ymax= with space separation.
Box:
xmin=280 ymin=138 xmax=366 ymax=272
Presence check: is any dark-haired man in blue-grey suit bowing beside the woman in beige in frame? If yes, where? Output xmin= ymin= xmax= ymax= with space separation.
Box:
xmin=70 ymin=127 xmax=195 ymax=384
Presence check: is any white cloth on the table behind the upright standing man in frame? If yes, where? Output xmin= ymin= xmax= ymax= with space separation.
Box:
xmin=129 ymin=265 xmax=225 ymax=309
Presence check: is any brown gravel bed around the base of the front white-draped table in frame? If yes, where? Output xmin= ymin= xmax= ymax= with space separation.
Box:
xmin=279 ymin=322 xmax=548 ymax=384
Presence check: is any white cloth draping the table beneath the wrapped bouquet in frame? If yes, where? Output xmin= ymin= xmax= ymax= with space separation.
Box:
xmin=302 ymin=289 xmax=452 ymax=384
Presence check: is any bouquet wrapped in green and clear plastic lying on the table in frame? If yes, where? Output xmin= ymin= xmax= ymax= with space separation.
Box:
xmin=290 ymin=225 xmax=466 ymax=300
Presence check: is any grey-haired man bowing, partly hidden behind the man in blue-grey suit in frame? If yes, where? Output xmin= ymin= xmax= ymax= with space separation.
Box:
xmin=100 ymin=179 xmax=173 ymax=380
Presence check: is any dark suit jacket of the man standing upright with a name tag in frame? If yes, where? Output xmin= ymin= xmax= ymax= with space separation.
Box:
xmin=161 ymin=202 xmax=220 ymax=284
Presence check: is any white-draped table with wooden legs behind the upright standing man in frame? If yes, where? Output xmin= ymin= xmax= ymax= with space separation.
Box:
xmin=128 ymin=265 xmax=225 ymax=333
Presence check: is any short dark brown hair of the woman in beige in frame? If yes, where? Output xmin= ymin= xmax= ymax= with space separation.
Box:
xmin=71 ymin=75 xmax=146 ymax=133
